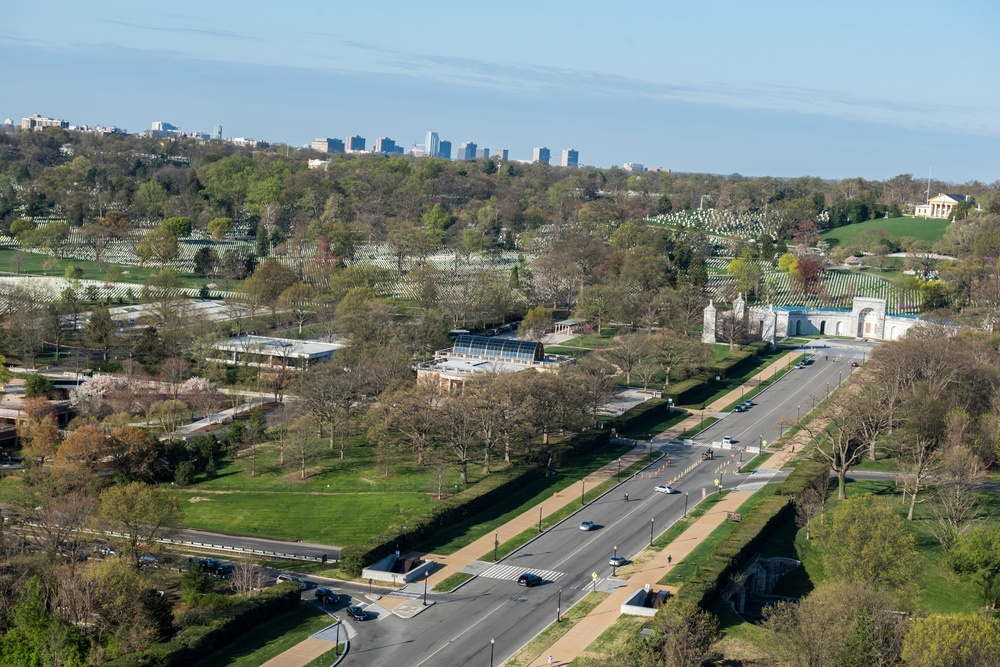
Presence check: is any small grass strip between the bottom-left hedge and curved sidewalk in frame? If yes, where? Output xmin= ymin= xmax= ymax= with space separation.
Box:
xmin=198 ymin=603 xmax=334 ymax=667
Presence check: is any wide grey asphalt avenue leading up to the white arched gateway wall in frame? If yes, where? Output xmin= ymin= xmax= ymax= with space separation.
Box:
xmin=346 ymin=341 xmax=870 ymax=667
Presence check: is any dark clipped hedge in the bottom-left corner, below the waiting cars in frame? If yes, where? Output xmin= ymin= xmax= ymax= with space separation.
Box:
xmin=104 ymin=581 xmax=302 ymax=667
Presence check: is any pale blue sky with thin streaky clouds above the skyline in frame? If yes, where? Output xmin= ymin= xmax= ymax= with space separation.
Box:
xmin=0 ymin=0 xmax=1000 ymax=184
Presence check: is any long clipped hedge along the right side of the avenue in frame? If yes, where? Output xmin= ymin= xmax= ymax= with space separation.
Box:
xmin=675 ymin=461 xmax=830 ymax=609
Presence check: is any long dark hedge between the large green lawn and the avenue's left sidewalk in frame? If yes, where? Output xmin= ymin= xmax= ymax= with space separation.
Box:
xmin=340 ymin=430 xmax=611 ymax=577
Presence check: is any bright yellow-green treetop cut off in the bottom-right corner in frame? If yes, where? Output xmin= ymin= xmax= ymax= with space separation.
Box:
xmin=903 ymin=614 xmax=1000 ymax=667
